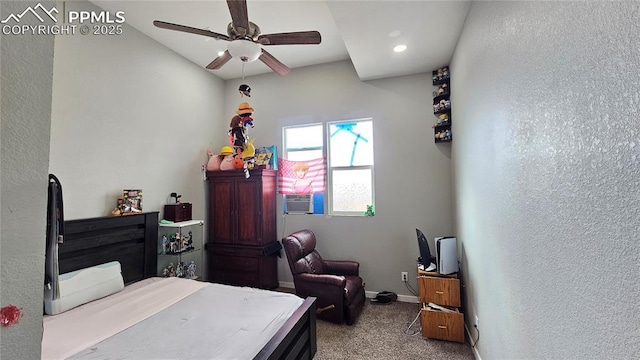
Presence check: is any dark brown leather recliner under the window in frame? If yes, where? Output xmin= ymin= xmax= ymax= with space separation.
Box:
xmin=282 ymin=230 xmax=365 ymax=325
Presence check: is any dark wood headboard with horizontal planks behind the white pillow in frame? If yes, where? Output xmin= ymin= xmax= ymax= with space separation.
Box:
xmin=58 ymin=212 xmax=158 ymax=284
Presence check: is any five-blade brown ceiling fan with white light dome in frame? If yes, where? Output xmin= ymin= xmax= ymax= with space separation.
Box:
xmin=153 ymin=0 xmax=321 ymax=75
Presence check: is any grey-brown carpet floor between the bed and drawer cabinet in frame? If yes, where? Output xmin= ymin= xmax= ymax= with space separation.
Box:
xmin=314 ymin=299 xmax=475 ymax=360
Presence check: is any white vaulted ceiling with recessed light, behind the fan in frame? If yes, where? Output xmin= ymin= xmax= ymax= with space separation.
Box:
xmin=91 ymin=0 xmax=471 ymax=80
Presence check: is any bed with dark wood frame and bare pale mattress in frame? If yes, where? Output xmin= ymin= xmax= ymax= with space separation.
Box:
xmin=42 ymin=212 xmax=316 ymax=359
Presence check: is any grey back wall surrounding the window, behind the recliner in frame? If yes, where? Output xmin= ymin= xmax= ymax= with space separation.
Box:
xmin=221 ymin=61 xmax=453 ymax=295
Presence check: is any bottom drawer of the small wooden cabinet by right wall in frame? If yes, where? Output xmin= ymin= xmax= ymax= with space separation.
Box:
xmin=420 ymin=307 xmax=464 ymax=343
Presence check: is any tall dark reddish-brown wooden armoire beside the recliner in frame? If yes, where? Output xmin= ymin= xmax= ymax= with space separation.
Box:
xmin=205 ymin=169 xmax=282 ymax=289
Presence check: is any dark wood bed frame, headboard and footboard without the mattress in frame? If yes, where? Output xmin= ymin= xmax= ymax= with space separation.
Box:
xmin=58 ymin=212 xmax=317 ymax=360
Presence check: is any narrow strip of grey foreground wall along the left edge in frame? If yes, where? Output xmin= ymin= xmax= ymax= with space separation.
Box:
xmin=0 ymin=1 xmax=54 ymax=359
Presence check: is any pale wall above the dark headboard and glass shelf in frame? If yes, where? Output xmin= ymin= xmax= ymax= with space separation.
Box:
xmin=50 ymin=1 xmax=226 ymax=219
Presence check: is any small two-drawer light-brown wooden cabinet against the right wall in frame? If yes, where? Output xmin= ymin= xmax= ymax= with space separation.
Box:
xmin=418 ymin=270 xmax=464 ymax=342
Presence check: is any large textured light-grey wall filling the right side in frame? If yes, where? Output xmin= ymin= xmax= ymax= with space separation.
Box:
xmin=451 ymin=1 xmax=640 ymax=359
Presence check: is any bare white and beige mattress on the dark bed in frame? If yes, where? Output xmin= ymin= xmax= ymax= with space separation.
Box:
xmin=42 ymin=278 xmax=303 ymax=360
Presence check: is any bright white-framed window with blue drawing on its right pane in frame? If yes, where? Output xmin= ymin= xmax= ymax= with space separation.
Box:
xmin=283 ymin=119 xmax=374 ymax=215
